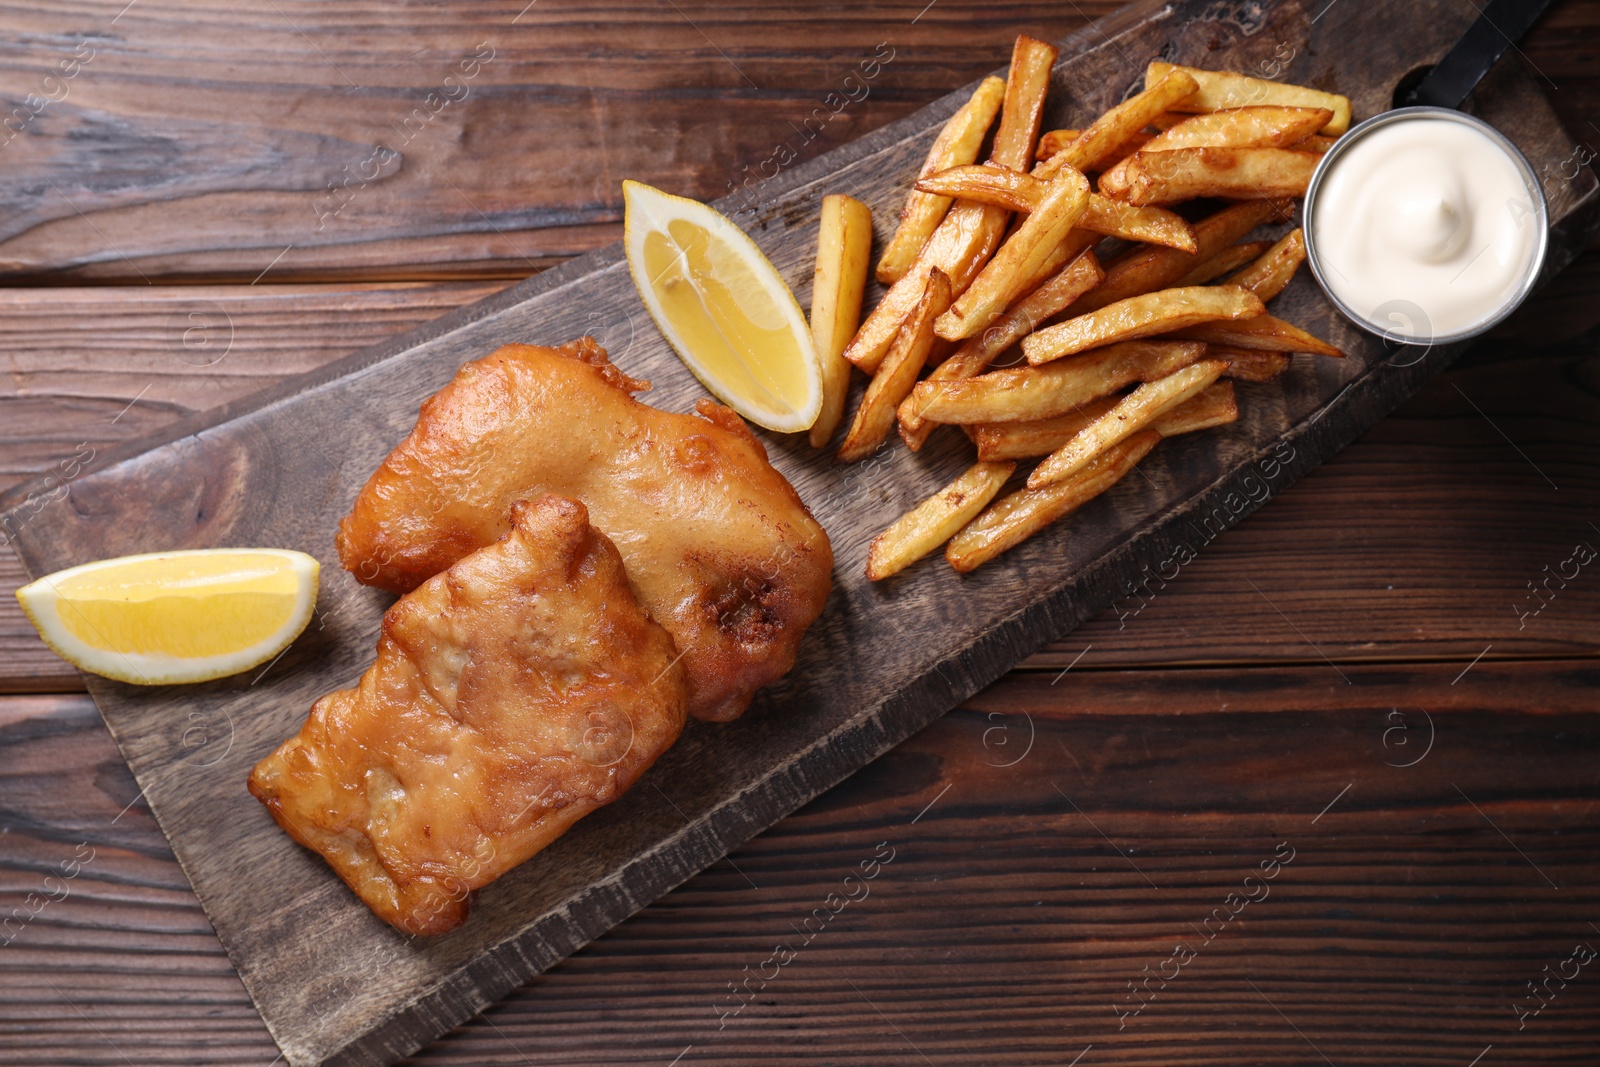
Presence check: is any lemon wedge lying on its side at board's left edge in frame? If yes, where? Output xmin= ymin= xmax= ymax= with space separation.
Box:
xmin=16 ymin=549 xmax=320 ymax=685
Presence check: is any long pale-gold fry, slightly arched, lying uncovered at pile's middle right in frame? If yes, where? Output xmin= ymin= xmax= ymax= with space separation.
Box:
xmin=1022 ymin=285 xmax=1267 ymax=366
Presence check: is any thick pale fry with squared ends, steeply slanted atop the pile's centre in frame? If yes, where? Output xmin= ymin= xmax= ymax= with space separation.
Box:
xmin=933 ymin=170 xmax=1090 ymax=341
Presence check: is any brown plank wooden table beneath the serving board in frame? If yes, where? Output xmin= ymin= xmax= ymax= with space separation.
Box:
xmin=0 ymin=0 xmax=1600 ymax=1067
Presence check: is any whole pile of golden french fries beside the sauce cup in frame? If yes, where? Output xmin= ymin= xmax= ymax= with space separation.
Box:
xmin=811 ymin=37 xmax=1350 ymax=581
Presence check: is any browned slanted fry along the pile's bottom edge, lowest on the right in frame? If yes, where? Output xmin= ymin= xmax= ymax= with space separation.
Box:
xmin=944 ymin=430 xmax=1162 ymax=573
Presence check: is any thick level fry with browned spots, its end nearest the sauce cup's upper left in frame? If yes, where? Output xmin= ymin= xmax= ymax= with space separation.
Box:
xmin=1101 ymin=149 xmax=1322 ymax=206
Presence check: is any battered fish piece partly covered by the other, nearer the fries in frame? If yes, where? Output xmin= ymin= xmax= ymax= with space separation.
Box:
xmin=339 ymin=338 xmax=834 ymax=721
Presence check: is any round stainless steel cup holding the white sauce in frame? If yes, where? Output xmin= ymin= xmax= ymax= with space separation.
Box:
xmin=1301 ymin=107 xmax=1550 ymax=344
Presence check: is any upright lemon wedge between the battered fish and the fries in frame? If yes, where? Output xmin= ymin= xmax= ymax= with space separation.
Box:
xmin=622 ymin=181 xmax=822 ymax=434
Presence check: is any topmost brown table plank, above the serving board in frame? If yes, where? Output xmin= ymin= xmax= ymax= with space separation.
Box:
xmin=0 ymin=0 xmax=1117 ymax=283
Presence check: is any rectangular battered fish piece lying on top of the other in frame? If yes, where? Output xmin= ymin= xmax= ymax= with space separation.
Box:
xmin=250 ymin=496 xmax=688 ymax=934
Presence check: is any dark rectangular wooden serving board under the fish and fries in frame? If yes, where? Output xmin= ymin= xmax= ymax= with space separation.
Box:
xmin=5 ymin=0 xmax=1597 ymax=1067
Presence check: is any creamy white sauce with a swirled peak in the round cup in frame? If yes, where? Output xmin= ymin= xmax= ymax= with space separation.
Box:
xmin=1312 ymin=115 xmax=1539 ymax=341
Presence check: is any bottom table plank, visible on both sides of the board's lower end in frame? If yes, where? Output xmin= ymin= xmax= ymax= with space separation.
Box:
xmin=0 ymin=661 xmax=1600 ymax=1067
